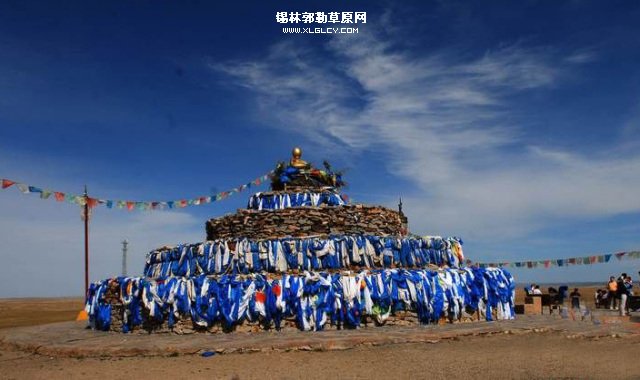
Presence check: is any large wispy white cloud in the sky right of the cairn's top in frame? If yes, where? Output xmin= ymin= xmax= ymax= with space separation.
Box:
xmin=214 ymin=33 xmax=640 ymax=243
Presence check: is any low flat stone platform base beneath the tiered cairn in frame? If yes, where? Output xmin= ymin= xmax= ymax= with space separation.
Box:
xmin=0 ymin=315 xmax=640 ymax=358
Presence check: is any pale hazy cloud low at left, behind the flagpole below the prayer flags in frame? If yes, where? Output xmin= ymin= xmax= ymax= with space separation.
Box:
xmin=0 ymin=174 xmax=204 ymax=297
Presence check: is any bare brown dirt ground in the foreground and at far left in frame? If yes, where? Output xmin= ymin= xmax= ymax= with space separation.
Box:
xmin=0 ymin=293 xmax=640 ymax=379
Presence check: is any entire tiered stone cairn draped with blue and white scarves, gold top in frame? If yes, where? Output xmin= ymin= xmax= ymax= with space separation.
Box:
xmin=86 ymin=148 xmax=514 ymax=333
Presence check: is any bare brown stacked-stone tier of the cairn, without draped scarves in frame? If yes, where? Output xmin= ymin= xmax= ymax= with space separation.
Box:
xmin=206 ymin=205 xmax=403 ymax=240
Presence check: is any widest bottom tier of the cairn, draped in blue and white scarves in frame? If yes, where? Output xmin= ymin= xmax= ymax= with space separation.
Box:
xmin=87 ymin=268 xmax=515 ymax=333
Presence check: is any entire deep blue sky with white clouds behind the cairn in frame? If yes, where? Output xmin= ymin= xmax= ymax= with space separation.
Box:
xmin=0 ymin=1 xmax=640 ymax=297
